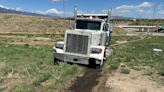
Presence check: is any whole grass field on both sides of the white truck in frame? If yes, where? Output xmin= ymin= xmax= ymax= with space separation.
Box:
xmin=0 ymin=35 xmax=164 ymax=92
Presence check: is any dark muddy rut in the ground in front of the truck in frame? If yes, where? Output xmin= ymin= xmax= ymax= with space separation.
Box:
xmin=69 ymin=69 xmax=102 ymax=92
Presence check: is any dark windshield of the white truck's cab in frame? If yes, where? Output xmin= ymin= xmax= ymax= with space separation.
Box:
xmin=76 ymin=20 xmax=101 ymax=30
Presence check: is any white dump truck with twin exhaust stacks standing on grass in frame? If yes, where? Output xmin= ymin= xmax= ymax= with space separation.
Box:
xmin=53 ymin=6 xmax=113 ymax=67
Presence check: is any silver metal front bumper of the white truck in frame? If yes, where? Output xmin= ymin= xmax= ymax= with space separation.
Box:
xmin=54 ymin=53 xmax=89 ymax=65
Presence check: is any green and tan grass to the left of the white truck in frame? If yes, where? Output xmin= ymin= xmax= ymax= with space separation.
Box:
xmin=0 ymin=44 xmax=85 ymax=92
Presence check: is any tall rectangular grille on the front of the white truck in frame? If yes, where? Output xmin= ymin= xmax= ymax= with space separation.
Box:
xmin=65 ymin=33 xmax=89 ymax=55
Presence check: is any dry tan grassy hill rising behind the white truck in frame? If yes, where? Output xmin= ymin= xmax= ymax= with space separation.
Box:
xmin=0 ymin=14 xmax=130 ymax=34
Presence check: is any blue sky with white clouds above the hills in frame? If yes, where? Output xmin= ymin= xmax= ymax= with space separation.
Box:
xmin=0 ymin=0 xmax=164 ymax=18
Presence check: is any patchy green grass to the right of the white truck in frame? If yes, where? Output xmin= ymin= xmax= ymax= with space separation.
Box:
xmin=104 ymin=36 xmax=164 ymax=85
